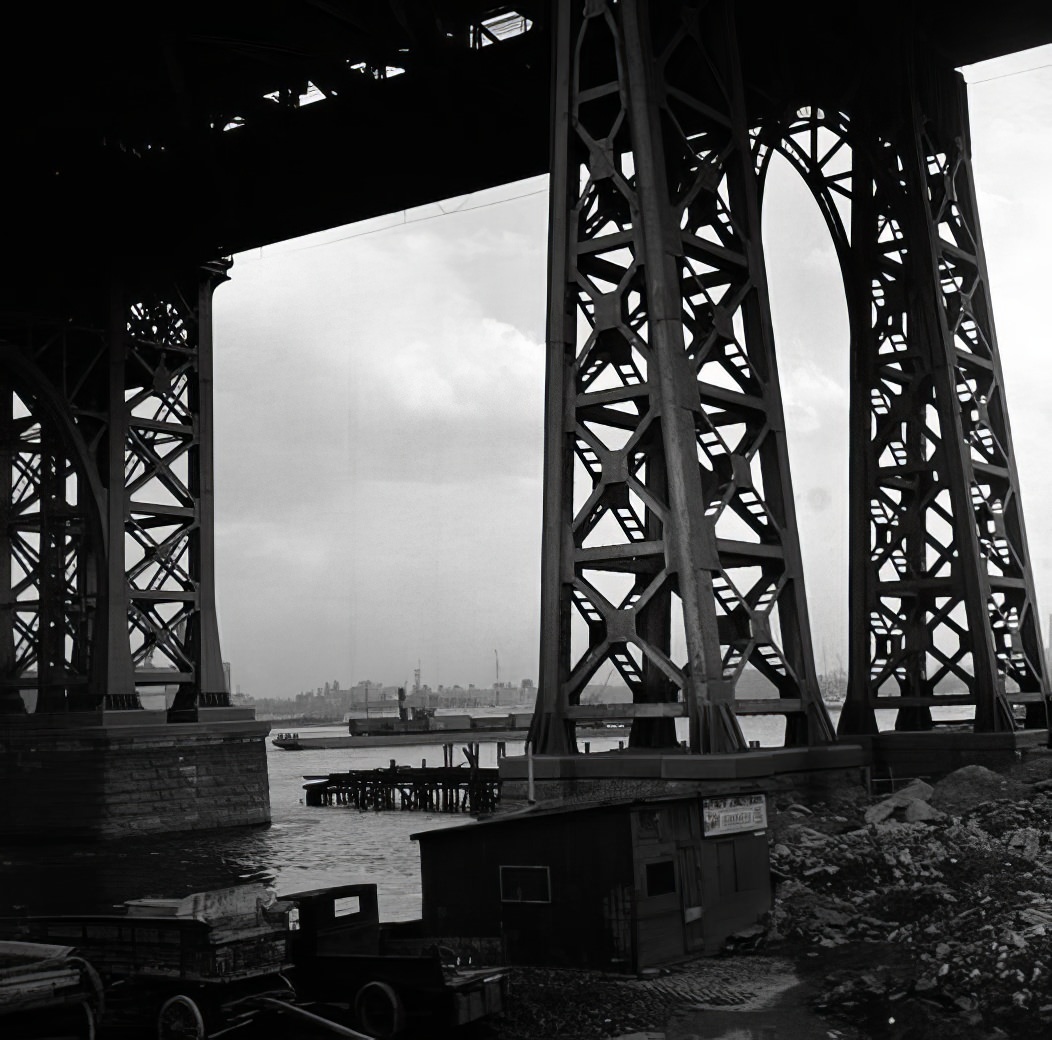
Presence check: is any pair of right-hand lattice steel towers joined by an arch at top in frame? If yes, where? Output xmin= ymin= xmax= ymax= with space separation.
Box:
xmin=531 ymin=0 xmax=1049 ymax=755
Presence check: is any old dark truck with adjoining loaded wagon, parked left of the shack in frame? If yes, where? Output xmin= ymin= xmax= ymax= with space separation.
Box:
xmin=4 ymin=884 xmax=507 ymax=1040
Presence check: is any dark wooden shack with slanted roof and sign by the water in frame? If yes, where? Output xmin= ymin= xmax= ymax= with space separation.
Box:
xmin=413 ymin=794 xmax=771 ymax=972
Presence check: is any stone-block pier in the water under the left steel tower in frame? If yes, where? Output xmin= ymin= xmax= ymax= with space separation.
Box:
xmin=0 ymin=708 xmax=270 ymax=841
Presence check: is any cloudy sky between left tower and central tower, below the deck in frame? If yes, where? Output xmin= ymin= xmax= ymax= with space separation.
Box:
xmin=209 ymin=192 xmax=546 ymax=696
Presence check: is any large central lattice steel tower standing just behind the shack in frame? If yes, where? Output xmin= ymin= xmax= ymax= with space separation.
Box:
xmin=532 ymin=0 xmax=832 ymax=752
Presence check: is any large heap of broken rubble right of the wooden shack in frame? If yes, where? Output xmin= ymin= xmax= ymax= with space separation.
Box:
xmin=766 ymin=766 xmax=1052 ymax=1038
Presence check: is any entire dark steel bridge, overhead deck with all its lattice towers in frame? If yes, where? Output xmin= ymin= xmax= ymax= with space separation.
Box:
xmin=0 ymin=0 xmax=1052 ymax=832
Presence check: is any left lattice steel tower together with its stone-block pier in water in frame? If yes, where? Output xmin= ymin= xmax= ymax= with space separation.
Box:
xmin=0 ymin=262 xmax=269 ymax=838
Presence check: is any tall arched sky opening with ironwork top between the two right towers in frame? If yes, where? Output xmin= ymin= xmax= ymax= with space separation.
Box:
xmin=742 ymin=107 xmax=859 ymax=706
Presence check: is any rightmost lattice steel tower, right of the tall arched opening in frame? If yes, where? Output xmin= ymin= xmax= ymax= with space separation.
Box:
xmin=839 ymin=59 xmax=1048 ymax=733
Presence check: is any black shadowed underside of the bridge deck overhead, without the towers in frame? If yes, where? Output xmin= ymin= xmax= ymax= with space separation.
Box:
xmin=0 ymin=0 xmax=1052 ymax=281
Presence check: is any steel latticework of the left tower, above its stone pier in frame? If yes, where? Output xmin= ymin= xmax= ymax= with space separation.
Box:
xmin=0 ymin=265 xmax=229 ymax=717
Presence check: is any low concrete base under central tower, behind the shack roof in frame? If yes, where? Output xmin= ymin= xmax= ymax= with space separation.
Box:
xmin=500 ymin=743 xmax=867 ymax=802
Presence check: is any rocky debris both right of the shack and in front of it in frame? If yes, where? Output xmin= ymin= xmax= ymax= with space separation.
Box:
xmin=487 ymin=754 xmax=1052 ymax=1040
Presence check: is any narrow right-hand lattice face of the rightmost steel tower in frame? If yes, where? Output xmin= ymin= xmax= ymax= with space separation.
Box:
xmin=907 ymin=60 xmax=1048 ymax=732
